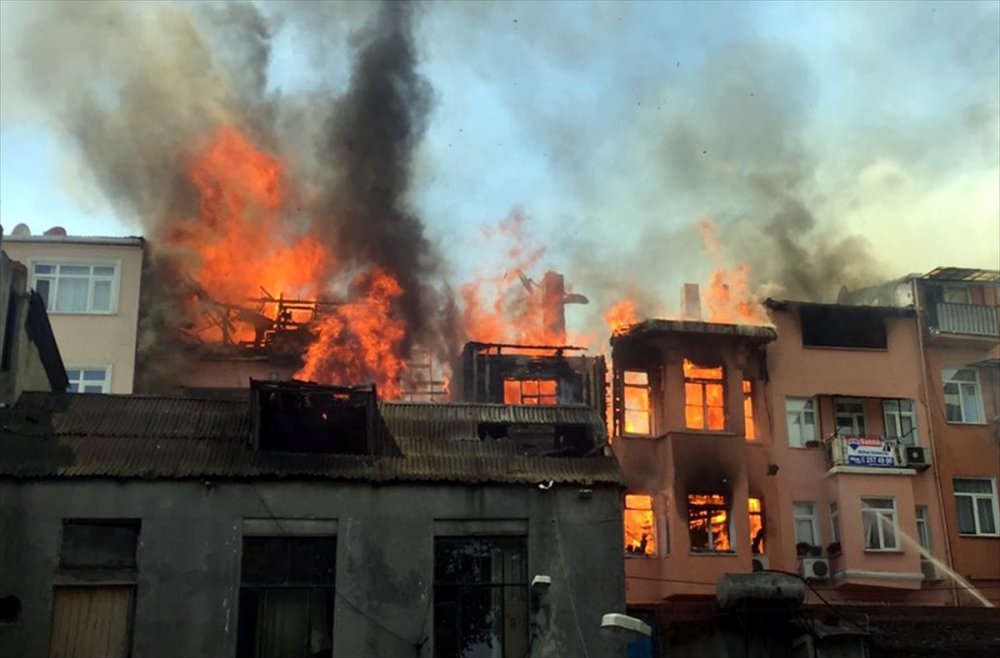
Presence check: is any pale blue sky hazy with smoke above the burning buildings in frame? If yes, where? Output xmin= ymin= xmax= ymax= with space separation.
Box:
xmin=0 ymin=2 xmax=1000 ymax=326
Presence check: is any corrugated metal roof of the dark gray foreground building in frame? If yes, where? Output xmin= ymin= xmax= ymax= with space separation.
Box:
xmin=0 ymin=393 xmax=624 ymax=486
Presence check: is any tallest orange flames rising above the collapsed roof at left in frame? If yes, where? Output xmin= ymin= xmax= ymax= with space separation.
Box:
xmin=165 ymin=126 xmax=406 ymax=398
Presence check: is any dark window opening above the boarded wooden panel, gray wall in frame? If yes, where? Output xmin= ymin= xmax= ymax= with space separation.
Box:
xmin=59 ymin=520 xmax=139 ymax=570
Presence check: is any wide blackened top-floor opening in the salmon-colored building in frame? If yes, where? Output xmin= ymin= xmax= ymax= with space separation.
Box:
xmin=800 ymin=306 xmax=888 ymax=350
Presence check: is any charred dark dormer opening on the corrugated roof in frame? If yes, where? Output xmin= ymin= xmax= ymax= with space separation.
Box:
xmin=252 ymin=381 xmax=375 ymax=455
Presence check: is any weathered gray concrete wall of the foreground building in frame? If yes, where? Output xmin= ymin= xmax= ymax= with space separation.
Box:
xmin=0 ymin=480 xmax=625 ymax=658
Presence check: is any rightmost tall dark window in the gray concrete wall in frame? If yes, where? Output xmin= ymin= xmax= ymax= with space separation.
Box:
xmin=434 ymin=536 xmax=529 ymax=658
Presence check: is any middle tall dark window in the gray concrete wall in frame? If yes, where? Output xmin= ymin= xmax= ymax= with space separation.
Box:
xmin=236 ymin=537 xmax=337 ymax=658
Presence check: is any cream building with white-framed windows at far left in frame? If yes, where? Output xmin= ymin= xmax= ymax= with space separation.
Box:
xmin=4 ymin=224 xmax=144 ymax=393
